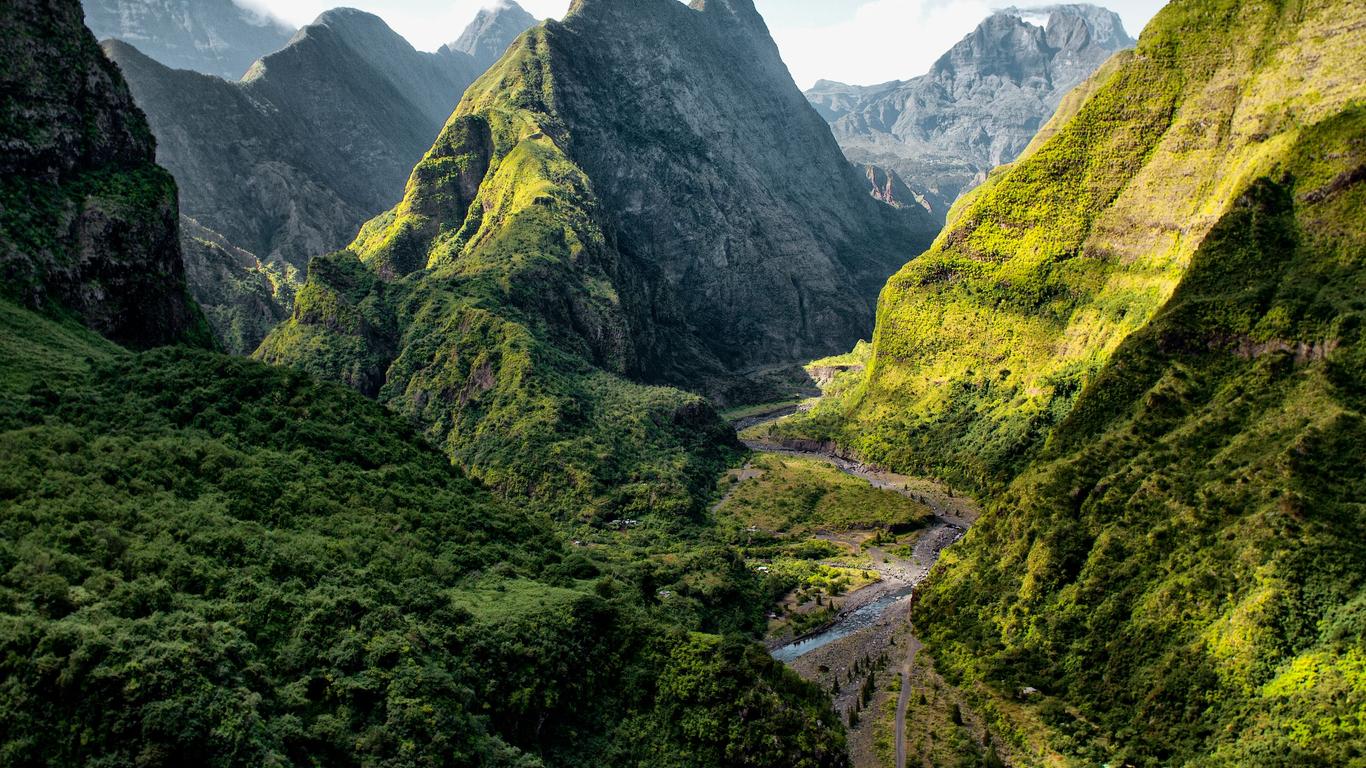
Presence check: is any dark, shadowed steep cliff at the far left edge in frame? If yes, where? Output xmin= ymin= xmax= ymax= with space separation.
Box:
xmin=0 ymin=0 xmax=209 ymax=347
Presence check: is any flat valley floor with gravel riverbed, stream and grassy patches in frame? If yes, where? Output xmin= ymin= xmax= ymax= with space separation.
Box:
xmin=712 ymin=400 xmax=990 ymax=768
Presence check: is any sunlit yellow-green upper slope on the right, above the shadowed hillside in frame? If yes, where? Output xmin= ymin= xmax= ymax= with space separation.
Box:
xmin=781 ymin=0 xmax=1366 ymax=484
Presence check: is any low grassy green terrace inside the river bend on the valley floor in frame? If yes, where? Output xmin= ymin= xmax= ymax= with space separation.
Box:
xmin=716 ymin=454 xmax=933 ymax=536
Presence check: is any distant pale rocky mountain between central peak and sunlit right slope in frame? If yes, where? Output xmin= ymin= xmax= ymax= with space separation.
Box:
xmin=806 ymin=5 xmax=1134 ymax=220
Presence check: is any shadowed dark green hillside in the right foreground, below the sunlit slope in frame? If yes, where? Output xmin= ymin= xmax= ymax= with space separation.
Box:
xmin=918 ymin=103 xmax=1366 ymax=768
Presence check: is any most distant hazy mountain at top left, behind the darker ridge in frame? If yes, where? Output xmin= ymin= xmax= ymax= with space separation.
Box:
xmin=83 ymin=0 xmax=294 ymax=81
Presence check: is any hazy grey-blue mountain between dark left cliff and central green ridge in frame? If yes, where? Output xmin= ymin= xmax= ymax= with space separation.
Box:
xmin=105 ymin=8 xmax=535 ymax=354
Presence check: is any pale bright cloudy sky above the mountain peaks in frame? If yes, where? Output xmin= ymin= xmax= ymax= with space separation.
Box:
xmin=239 ymin=0 xmax=1165 ymax=87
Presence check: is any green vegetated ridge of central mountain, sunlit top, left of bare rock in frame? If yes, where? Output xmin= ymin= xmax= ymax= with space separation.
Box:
xmin=258 ymin=22 xmax=738 ymax=519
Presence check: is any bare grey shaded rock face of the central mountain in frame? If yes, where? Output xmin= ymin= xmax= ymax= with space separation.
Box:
xmin=550 ymin=0 xmax=936 ymax=387
